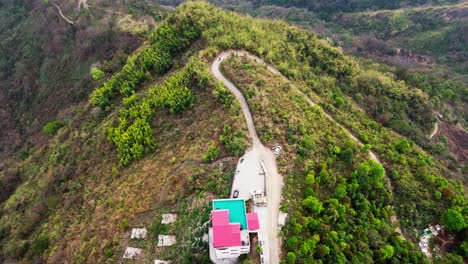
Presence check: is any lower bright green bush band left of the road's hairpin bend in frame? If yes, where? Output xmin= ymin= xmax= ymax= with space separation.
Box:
xmin=107 ymin=62 xmax=207 ymax=166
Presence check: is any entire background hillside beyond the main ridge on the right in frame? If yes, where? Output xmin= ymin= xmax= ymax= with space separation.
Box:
xmin=175 ymin=0 xmax=468 ymax=186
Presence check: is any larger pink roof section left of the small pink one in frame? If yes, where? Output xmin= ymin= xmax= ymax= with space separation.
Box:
xmin=211 ymin=210 xmax=242 ymax=248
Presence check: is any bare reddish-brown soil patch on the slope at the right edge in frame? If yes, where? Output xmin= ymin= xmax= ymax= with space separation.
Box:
xmin=438 ymin=122 xmax=468 ymax=163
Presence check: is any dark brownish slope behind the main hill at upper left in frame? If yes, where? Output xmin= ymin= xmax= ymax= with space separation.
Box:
xmin=0 ymin=0 xmax=162 ymax=158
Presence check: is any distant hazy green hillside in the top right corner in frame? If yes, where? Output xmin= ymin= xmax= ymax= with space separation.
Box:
xmin=333 ymin=3 xmax=468 ymax=74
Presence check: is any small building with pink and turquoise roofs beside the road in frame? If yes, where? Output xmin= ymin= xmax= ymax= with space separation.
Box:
xmin=209 ymin=199 xmax=260 ymax=263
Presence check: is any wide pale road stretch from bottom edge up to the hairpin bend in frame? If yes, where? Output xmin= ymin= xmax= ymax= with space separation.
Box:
xmin=211 ymin=51 xmax=283 ymax=263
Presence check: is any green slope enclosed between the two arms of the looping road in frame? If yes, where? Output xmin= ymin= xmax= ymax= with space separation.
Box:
xmin=222 ymin=55 xmax=425 ymax=263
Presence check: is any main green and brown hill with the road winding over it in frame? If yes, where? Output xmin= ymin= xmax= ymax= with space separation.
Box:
xmin=0 ymin=2 xmax=468 ymax=263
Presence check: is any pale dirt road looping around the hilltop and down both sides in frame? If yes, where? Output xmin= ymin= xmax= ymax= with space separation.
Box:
xmin=211 ymin=50 xmax=407 ymax=251
